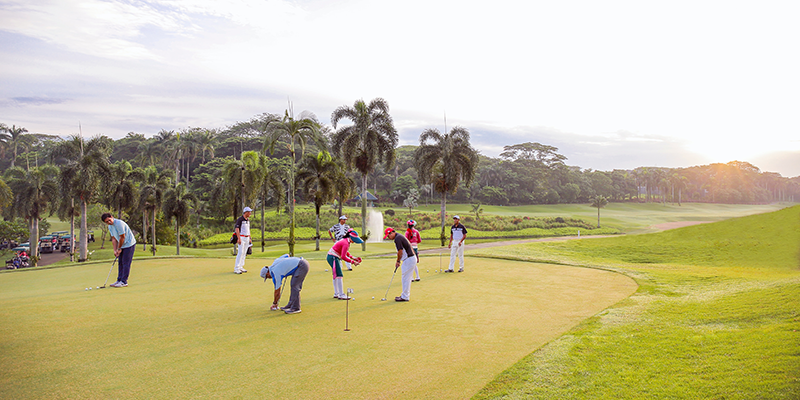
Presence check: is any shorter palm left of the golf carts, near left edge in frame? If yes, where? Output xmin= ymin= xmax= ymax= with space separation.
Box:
xmin=7 ymin=165 xmax=60 ymax=266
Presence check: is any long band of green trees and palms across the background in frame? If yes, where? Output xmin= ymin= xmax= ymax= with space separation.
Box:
xmin=0 ymin=103 xmax=800 ymax=260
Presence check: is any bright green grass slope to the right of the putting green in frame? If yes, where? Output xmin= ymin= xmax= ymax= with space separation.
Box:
xmin=475 ymin=206 xmax=800 ymax=399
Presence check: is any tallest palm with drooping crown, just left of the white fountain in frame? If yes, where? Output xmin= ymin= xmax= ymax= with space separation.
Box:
xmin=331 ymin=97 xmax=398 ymax=250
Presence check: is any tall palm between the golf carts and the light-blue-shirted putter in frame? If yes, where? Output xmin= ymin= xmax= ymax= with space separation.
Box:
xmin=53 ymin=135 xmax=113 ymax=261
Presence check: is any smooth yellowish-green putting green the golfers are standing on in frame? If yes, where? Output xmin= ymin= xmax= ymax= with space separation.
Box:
xmin=0 ymin=255 xmax=637 ymax=399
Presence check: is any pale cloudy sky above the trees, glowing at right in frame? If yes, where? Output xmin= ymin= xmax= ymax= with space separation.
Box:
xmin=0 ymin=0 xmax=800 ymax=177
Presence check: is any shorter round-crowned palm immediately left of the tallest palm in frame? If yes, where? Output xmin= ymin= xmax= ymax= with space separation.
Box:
xmin=297 ymin=151 xmax=339 ymax=251
